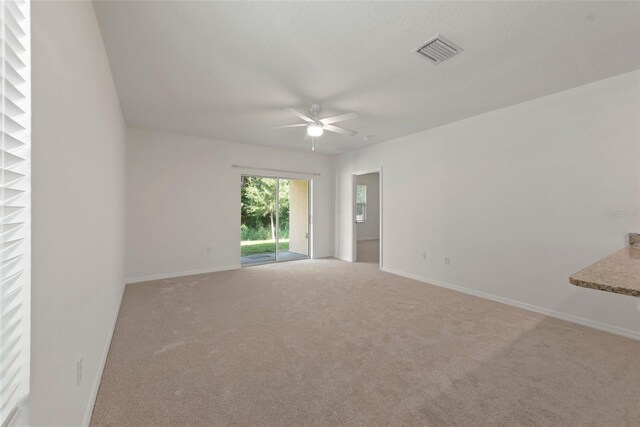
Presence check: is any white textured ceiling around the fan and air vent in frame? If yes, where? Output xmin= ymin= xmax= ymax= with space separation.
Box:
xmin=95 ymin=1 xmax=640 ymax=153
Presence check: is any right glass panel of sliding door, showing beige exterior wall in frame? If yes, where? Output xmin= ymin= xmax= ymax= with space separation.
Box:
xmin=278 ymin=179 xmax=309 ymax=261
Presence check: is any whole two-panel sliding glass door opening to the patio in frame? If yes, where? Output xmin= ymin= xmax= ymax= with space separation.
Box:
xmin=240 ymin=175 xmax=311 ymax=266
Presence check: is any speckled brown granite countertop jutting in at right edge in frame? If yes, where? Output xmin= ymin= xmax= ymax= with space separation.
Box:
xmin=569 ymin=235 xmax=640 ymax=297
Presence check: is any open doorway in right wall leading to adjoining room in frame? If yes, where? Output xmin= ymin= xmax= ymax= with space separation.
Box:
xmin=353 ymin=169 xmax=382 ymax=268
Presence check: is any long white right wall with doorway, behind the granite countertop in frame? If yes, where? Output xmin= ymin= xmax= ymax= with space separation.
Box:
xmin=335 ymin=71 xmax=640 ymax=337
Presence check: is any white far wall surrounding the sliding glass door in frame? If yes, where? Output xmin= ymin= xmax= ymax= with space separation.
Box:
xmin=126 ymin=129 xmax=334 ymax=281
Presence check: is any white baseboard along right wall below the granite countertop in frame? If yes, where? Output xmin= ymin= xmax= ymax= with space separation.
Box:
xmin=382 ymin=267 xmax=640 ymax=341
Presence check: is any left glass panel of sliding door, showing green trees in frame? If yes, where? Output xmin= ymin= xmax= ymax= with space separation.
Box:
xmin=240 ymin=176 xmax=278 ymax=265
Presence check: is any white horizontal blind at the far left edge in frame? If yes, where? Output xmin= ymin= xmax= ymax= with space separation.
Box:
xmin=0 ymin=0 xmax=31 ymax=426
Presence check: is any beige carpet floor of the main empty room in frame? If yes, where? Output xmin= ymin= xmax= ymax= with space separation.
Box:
xmin=91 ymin=259 xmax=640 ymax=426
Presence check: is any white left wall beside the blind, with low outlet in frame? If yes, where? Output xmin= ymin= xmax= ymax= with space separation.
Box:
xmin=29 ymin=2 xmax=126 ymax=426
